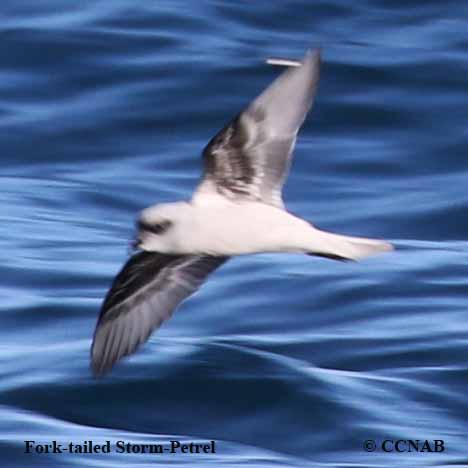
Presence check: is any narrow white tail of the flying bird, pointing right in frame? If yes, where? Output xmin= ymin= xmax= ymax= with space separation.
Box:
xmin=308 ymin=229 xmax=393 ymax=261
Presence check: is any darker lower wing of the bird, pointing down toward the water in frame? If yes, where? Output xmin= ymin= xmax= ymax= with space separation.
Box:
xmin=91 ymin=252 xmax=228 ymax=375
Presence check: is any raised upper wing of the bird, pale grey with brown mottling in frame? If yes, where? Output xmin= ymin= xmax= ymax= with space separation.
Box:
xmin=194 ymin=50 xmax=320 ymax=207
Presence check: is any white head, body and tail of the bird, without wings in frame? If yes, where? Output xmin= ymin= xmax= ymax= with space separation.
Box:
xmin=140 ymin=195 xmax=392 ymax=260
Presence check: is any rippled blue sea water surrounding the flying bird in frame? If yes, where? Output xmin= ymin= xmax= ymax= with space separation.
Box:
xmin=0 ymin=0 xmax=468 ymax=468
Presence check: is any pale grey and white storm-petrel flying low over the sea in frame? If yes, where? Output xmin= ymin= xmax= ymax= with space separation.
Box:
xmin=91 ymin=49 xmax=393 ymax=377
